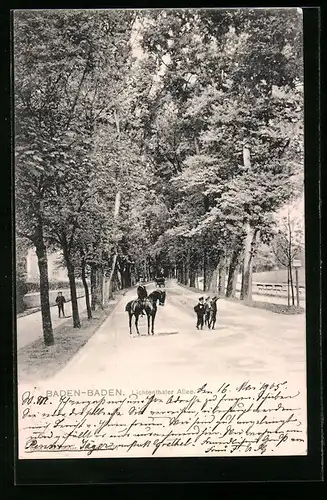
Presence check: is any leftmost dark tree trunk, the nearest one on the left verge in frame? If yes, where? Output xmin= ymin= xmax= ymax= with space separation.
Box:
xmin=35 ymin=232 xmax=54 ymax=346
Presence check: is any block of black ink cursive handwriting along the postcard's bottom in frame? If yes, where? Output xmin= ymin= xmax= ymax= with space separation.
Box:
xmin=19 ymin=380 xmax=306 ymax=458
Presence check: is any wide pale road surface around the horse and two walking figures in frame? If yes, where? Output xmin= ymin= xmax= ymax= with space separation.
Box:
xmin=52 ymin=282 xmax=305 ymax=388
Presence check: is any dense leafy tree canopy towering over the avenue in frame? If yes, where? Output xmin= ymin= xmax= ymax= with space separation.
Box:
xmin=14 ymin=9 xmax=303 ymax=343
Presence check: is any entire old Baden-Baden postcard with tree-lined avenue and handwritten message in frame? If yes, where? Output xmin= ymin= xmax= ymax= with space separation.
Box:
xmin=13 ymin=7 xmax=314 ymax=460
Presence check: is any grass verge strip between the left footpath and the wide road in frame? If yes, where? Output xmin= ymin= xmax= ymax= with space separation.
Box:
xmin=17 ymin=291 xmax=126 ymax=382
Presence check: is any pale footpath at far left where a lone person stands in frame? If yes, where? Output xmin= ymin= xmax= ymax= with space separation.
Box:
xmin=17 ymin=297 xmax=86 ymax=350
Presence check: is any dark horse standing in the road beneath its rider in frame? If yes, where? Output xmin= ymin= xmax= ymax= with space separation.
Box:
xmin=125 ymin=290 xmax=166 ymax=335
